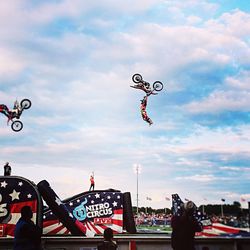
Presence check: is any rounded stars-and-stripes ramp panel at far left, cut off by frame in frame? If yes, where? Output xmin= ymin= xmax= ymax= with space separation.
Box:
xmin=0 ymin=177 xmax=41 ymax=237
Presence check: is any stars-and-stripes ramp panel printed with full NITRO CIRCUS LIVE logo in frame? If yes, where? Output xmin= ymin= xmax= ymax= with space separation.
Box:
xmin=43 ymin=191 xmax=123 ymax=237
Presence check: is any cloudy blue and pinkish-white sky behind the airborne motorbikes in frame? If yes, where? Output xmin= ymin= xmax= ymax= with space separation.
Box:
xmin=0 ymin=0 xmax=250 ymax=208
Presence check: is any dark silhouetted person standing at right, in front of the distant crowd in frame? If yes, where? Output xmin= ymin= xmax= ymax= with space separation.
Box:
xmin=171 ymin=201 xmax=202 ymax=250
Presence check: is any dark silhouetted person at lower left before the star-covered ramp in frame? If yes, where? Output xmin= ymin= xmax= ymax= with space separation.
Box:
xmin=13 ymin=206 xmax=42 ymax=250
